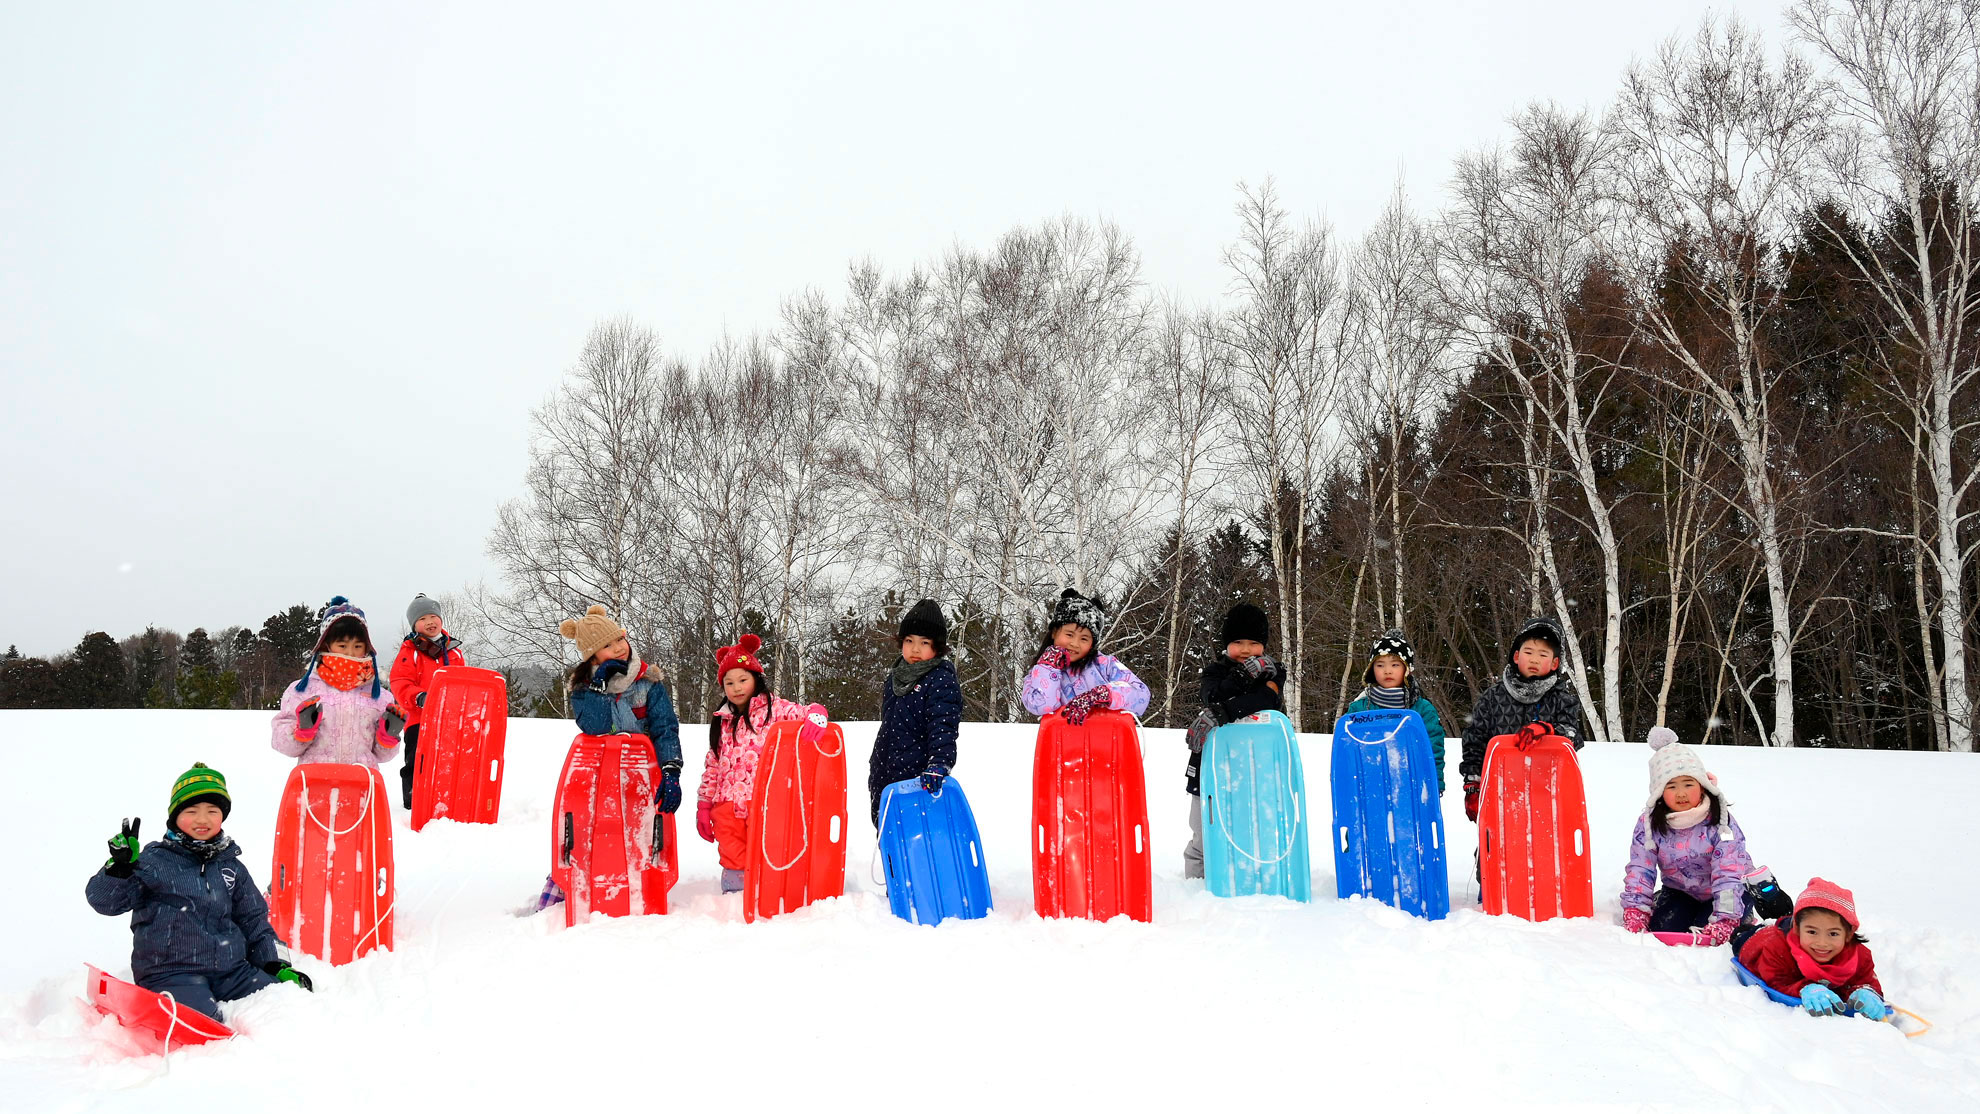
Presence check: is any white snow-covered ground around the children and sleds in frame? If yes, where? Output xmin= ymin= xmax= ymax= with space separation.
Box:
xmin=0 ymin=710 xmax=1980 ymax=1114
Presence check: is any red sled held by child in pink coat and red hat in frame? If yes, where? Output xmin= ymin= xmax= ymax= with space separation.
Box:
xmin=743 ymin=710 xmax=845 ymax=920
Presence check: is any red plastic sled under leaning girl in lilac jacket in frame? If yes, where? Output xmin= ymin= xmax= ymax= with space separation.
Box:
xmin=1032 ymin=712 xmax=1154 ymax=920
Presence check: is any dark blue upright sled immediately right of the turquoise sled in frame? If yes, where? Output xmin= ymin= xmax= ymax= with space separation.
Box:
xmin=1331 ymin=708 xmax=1451 ymax=920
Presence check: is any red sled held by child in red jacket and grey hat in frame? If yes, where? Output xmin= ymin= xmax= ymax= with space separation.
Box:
xmin=412 ymin=665 xmax=509 ymax=831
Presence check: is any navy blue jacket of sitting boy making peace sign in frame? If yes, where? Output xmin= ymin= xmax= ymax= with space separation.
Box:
xmin=83 ymin=839 xmax=277 ymax=985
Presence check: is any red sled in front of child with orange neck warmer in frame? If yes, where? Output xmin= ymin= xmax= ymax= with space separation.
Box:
xmin=267 ymin=762 xmax=396 ymax=964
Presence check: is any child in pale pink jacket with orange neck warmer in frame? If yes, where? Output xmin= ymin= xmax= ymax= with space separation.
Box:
xmin=273 ymin=596 xmax=406 ymax=770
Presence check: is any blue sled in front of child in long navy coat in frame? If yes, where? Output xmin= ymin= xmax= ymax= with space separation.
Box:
xmin=879 ymin=778 xmax=990 ymax=924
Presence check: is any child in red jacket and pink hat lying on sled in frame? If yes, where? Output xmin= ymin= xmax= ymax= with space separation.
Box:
xmin=1733 ymin=879 xmax=1889 ymax=1021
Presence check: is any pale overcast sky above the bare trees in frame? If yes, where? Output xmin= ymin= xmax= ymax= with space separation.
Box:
xmin=0 ymin=0 xmax=1784 ymax=653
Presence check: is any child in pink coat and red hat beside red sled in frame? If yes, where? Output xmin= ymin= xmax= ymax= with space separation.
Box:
xmin=695 ymin=635 xmax=804 ymax=894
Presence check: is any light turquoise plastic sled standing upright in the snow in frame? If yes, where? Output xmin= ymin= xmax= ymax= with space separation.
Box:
xmin=1202 ymin=712 xmax=1313 ymax=900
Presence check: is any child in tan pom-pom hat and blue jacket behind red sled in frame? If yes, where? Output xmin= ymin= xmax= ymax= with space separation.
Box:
xmin=537 ymin=603 xmax=681 ymax=910
